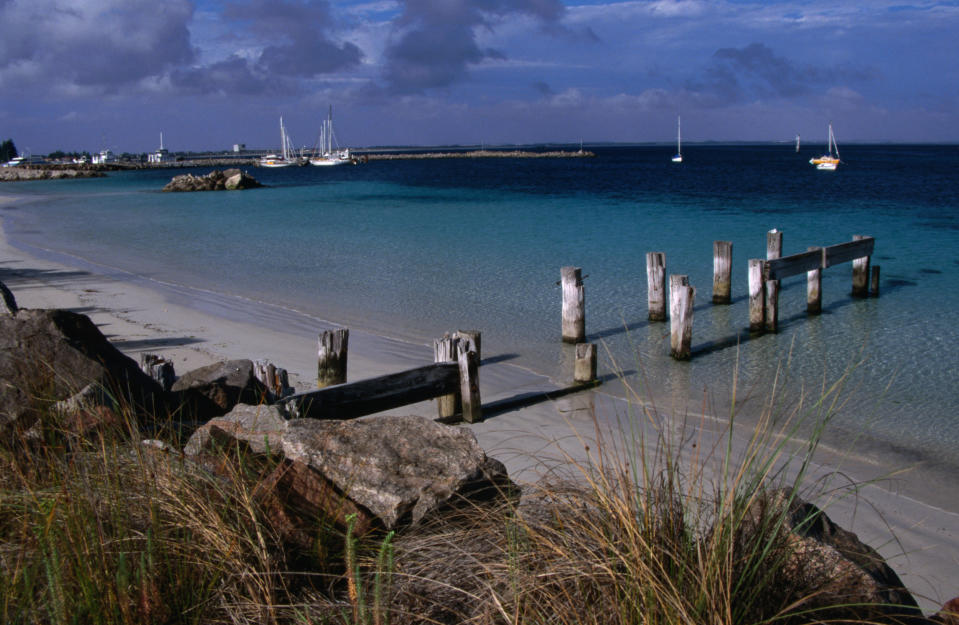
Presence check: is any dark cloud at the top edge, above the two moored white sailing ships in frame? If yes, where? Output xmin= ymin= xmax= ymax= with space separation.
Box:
xmin=224 ymin=0 xmax=363 ymax=78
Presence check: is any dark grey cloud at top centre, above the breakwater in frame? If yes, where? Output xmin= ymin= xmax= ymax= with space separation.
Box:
xmin=385 ymin=0 xmax=565 ymax=93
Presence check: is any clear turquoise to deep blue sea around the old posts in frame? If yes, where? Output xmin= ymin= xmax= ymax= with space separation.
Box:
xmin=0 ymin=144 xmax=959 ymax=478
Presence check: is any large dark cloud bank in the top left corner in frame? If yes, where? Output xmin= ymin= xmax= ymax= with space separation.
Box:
xmin=0 ymin=0 xmax=195 ymax=92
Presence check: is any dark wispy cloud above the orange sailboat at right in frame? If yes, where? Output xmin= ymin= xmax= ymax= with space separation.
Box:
xmin=691 ymin=43 xmax=870 ymax=103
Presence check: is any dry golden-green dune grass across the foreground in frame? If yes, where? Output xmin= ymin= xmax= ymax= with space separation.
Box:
xmin=0 ymin=356 xmax=916 ymax=625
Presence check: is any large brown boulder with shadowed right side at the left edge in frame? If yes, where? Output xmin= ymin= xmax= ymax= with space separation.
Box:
xmin=0 ymin=309 xmax=163 ymax=433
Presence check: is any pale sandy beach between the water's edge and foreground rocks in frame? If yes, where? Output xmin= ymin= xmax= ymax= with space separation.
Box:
xmin=0 ymin=195 xmax=959 ymax=612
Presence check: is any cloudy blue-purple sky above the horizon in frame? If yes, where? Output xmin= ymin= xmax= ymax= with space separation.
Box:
xmin=0 ymin=0 xmax=959 ymax=154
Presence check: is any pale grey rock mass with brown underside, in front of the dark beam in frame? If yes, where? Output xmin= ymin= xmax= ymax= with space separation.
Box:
xmin=184 ymin=406 xmax=514 ymax=529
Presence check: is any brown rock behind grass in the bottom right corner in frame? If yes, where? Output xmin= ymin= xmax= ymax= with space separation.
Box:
xmin=742 ymin=490 xmax=922 ymax=622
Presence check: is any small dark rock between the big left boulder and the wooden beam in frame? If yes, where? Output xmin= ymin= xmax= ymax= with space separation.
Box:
xmin=170 ymin=360 xmax=266 ymax=421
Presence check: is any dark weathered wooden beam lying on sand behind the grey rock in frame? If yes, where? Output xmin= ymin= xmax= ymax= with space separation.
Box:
xmin=283 ymin=362 xmax=460 ymax=419
